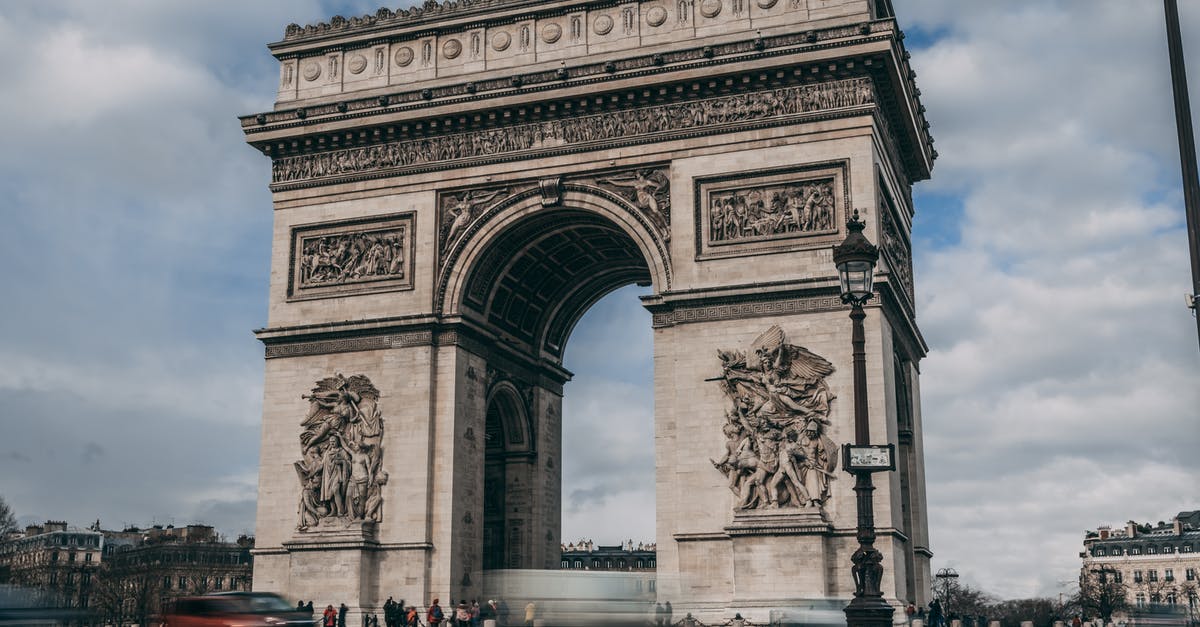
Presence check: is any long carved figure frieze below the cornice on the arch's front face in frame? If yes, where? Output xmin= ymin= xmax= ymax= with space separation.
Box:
xmin=271 ymin=77 xmax=875 ymax=187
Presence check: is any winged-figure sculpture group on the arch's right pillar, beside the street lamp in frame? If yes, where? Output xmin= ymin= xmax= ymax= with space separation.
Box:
xmin=709 ymin=326 xmax=838 ymax=510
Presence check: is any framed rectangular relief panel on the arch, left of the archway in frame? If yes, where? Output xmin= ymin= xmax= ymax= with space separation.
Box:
xmin=288 ymin=211 xmax=416 ymax=300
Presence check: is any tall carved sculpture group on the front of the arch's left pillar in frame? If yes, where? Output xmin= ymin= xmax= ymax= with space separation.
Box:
xmin=293 ymin=375 xmax=388 ymax=532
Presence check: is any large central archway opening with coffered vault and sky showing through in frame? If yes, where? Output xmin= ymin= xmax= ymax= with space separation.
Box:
xmin=461 ymin=208 xmax=654 ymax=589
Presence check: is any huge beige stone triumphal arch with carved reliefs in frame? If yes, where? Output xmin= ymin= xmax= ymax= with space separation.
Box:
xmin=241 ymin=0 xmax=936 ymax=621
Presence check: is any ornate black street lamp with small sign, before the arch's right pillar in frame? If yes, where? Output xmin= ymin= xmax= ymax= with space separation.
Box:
xmin=833 ymin=209 xmax=895 ymax=627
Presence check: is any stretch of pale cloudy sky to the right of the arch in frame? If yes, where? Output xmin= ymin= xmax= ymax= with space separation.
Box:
xmin=896 ymin=2 xmax=1200 ymax=597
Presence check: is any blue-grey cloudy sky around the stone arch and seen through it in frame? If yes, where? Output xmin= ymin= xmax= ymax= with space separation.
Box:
xmin=0 ymin=0 xmax=1200 ymax=597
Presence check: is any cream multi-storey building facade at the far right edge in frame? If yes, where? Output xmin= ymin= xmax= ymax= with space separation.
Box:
xmin=1079 ymin=510 xmax=1200 ymax=619
